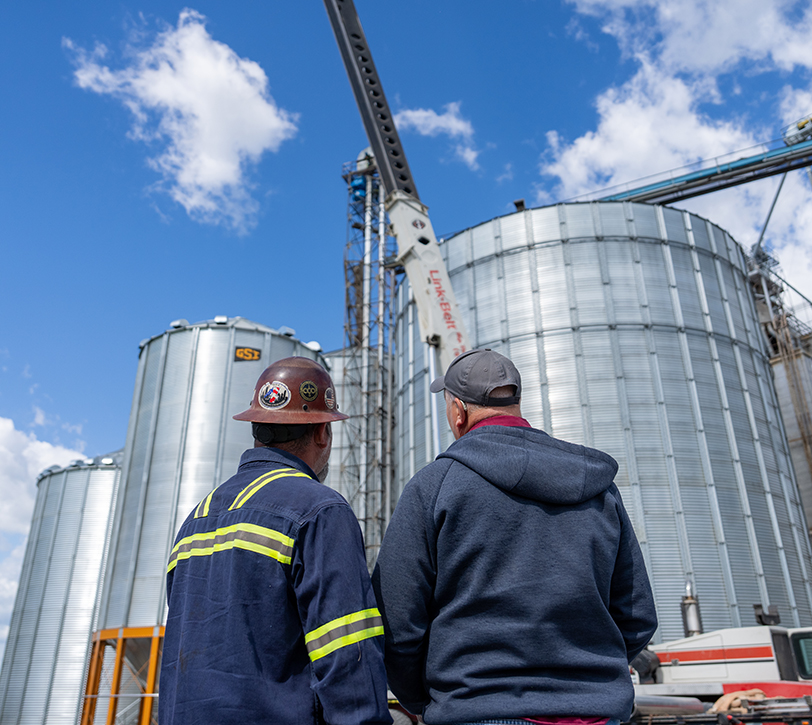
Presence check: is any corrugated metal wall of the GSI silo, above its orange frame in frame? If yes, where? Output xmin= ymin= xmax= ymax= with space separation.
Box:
xmin=101 ymin=318 xmax=326 ymax=628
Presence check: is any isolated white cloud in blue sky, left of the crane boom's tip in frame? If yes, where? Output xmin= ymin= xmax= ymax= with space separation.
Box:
xmin=63 ymin=9 xmax=298 ymax=231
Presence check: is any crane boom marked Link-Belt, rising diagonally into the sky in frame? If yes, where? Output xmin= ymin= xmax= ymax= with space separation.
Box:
xmin=324 ymin=0 xmax=470 ymax=370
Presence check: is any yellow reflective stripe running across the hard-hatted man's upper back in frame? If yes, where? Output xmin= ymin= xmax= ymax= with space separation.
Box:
xmin=167 ymin=523 xmax=296 ymax=573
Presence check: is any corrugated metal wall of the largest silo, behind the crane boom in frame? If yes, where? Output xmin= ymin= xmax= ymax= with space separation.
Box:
xmin=395 ymin=203 xmax=812 ymax=641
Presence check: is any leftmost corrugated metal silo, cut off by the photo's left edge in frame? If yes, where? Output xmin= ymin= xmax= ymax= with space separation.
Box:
xmin=0 ymin=458 xmax=121 ymax=725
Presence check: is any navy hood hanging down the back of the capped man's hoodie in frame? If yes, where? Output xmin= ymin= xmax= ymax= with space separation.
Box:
xmin=438 ymin=425 xmax=617 ymax=505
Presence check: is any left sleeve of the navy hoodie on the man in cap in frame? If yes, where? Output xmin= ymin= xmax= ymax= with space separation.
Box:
xmin=372 ymin=463 xmax=440 ymax=714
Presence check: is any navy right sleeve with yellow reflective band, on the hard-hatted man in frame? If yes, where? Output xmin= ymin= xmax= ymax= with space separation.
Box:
xmin=292 ymin=502 xmax=392 ymax=725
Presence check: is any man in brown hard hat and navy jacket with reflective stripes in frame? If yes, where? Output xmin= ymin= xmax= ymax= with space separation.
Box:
xmin=159 ymin=357 xmax=392 ymax=725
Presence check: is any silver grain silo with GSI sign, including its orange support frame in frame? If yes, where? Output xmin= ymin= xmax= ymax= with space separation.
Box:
xmin=83 ymin=317 xmax=320 ymax=723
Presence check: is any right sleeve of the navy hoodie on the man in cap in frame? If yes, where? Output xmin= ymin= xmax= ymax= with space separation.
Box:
xmin=609 ymin=485 xmax=657 ymax=662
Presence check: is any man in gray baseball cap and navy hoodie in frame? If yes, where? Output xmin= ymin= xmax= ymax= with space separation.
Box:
xmin=373 ymin=350 xmax=657 ymax=725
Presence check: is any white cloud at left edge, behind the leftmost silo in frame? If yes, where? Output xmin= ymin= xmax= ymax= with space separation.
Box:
xmin=0 ymin=418 xmax=82 ymax=651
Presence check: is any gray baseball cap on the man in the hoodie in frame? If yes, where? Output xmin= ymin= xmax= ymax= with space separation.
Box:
xmin=429 ymin=348 xmax=522 ymax=408
